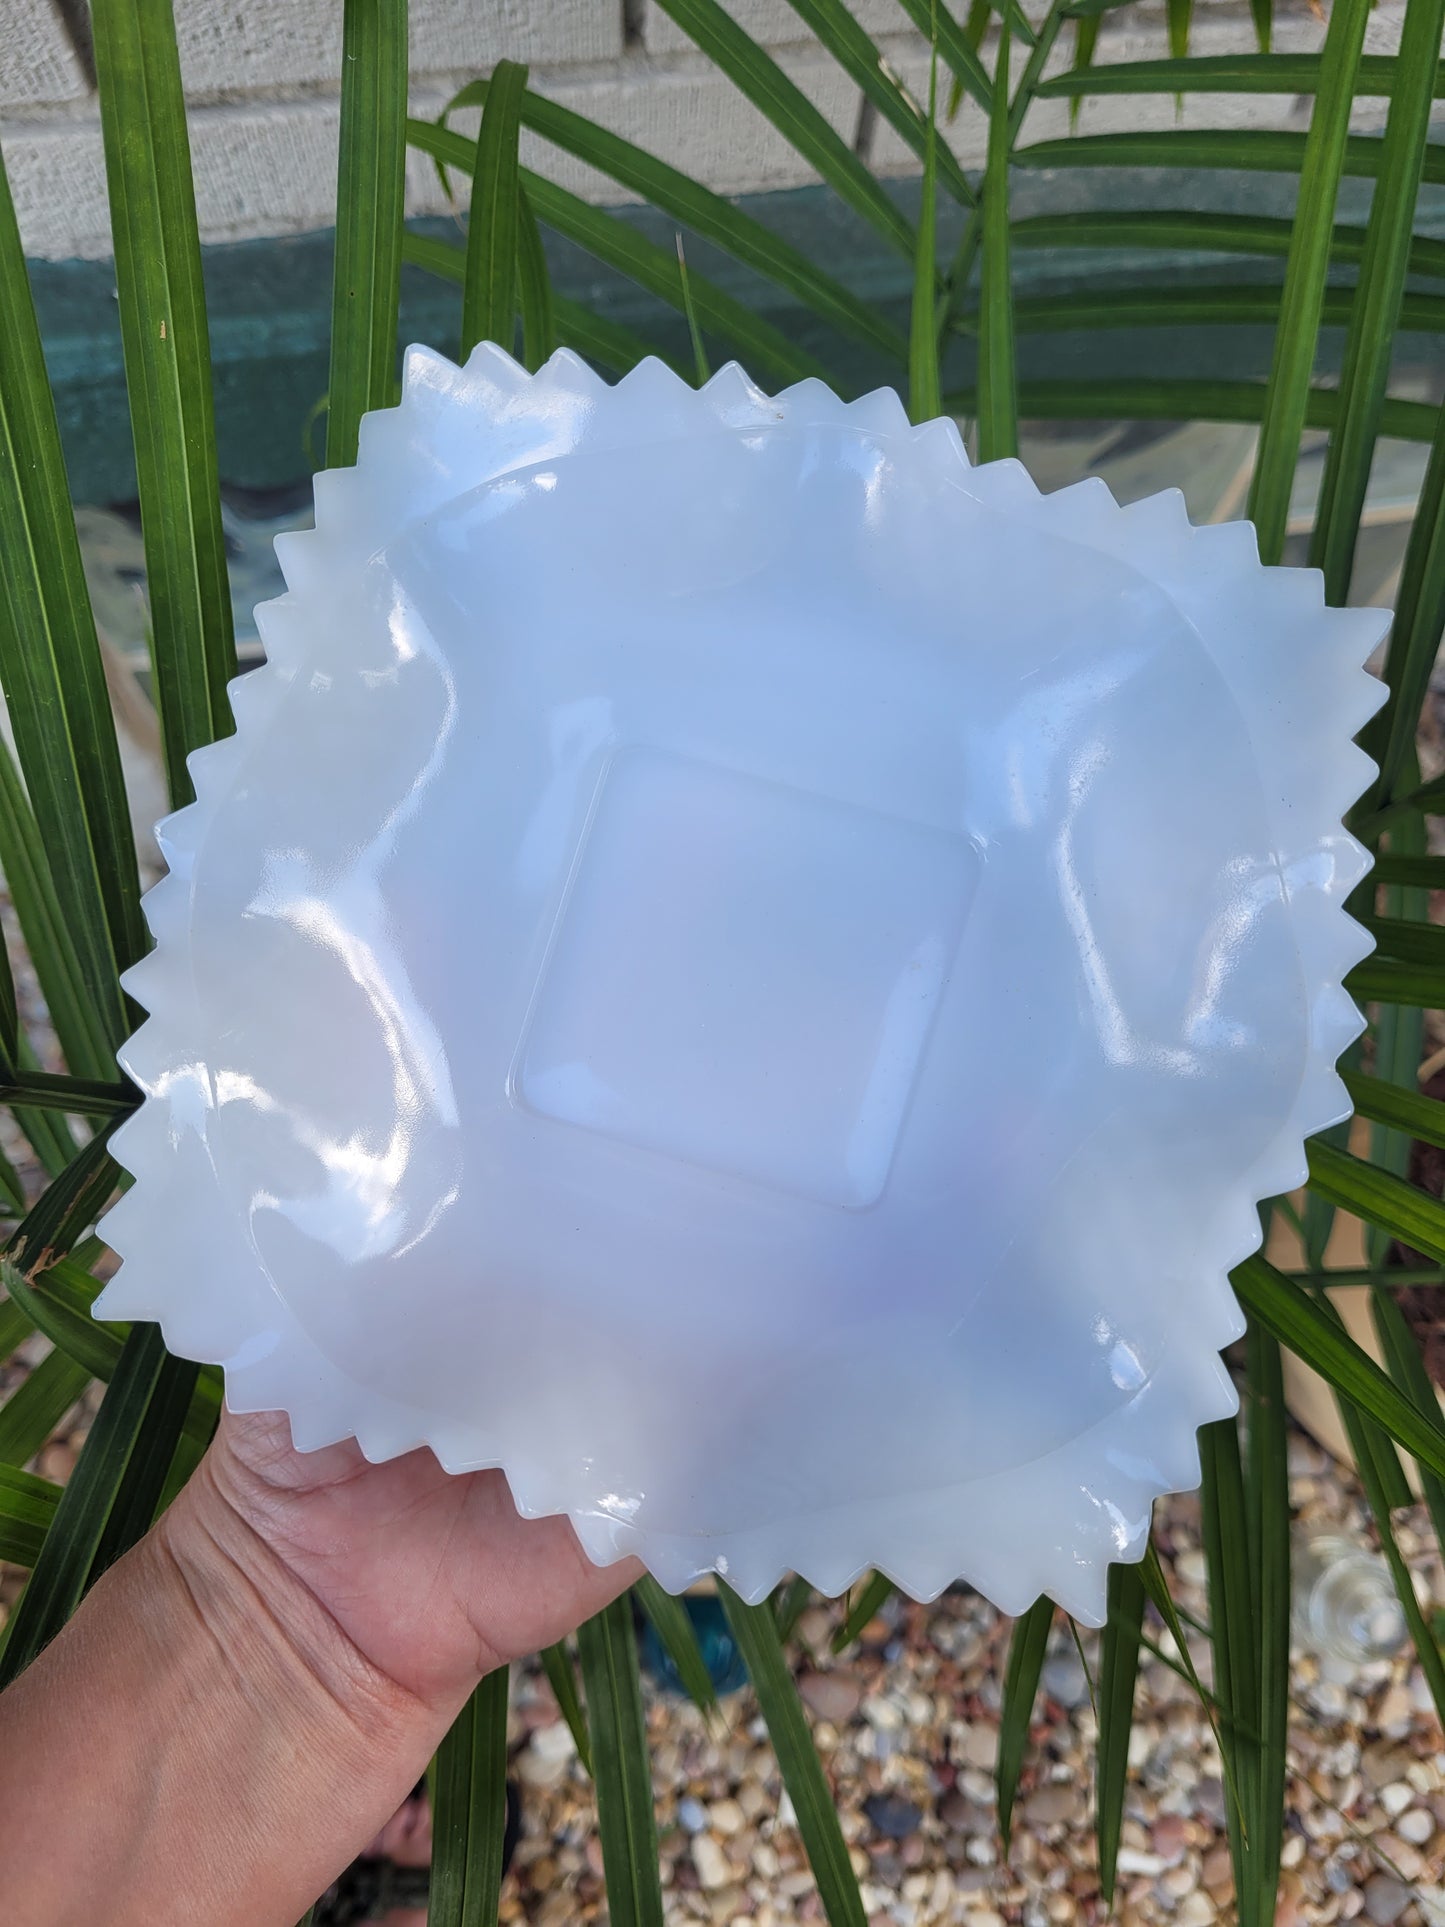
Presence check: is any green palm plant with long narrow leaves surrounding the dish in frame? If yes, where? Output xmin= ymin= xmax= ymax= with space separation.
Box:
xmin=0 ymin=0 xmax=1445 ymax=1927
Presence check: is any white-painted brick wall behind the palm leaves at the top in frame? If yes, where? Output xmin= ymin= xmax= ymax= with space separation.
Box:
xmin=0 ymin=0 xmax=1379 ymax=258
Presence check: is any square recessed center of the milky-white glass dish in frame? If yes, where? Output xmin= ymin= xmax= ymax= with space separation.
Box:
xmin=514 ymin=750 xmax=979 ymax=1206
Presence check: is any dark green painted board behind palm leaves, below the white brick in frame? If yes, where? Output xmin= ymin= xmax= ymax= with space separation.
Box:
xmin=31 ymin=170 xmax=1445 ymax=503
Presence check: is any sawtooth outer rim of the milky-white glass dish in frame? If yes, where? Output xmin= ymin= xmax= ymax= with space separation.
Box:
xmin=96 ymin=343 xmax=1389 ymax=1624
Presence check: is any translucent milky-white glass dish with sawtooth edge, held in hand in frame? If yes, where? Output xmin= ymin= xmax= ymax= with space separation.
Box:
xmin=100 ymin=347 xmax=1385 ymax=1623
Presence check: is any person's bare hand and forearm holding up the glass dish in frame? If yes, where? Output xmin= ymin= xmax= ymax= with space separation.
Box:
xmin=0 ymin=1412 xmax=638 ymax=1927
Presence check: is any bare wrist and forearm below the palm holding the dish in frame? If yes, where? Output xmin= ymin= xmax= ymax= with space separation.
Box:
xmin=0 ymin=1478 xmax=447 ymax=1927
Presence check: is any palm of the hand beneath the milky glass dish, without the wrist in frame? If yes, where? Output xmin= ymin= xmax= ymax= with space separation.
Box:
xmin=200 ymin=1411 xmax=640 ymax=1703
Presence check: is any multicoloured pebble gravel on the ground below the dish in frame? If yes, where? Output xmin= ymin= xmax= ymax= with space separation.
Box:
xmin=489 ymin=1438 xmax=1445 ymax=1927
